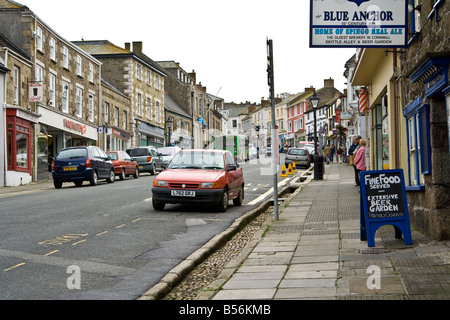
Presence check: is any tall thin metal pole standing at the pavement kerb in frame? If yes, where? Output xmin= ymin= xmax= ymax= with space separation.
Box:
xmin=267 ymin=39 xmax=278 ymax=220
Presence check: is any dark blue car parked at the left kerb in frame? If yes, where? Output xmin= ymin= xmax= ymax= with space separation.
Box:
xmin=52 ymin=146 xmax=115 ymax=189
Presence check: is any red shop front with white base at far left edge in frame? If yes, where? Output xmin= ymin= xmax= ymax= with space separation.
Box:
xmin=5 ymin=107 xmax=39 ymax=187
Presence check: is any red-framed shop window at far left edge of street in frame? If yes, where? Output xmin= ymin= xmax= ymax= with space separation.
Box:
xmin=7 ymin=117 xmax=31 ymax=172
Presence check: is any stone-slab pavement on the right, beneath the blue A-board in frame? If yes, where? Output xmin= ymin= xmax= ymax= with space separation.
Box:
xmin=189 ymin=163 xmax=450 ymax=300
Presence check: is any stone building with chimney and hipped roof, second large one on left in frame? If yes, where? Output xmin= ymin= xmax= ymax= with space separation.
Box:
xmin=74 ymin=40 xmax=167 ymax=147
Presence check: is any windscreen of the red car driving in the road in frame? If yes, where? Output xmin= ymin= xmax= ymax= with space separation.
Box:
xmin=169 ymin=151 xmax=225 ymax=170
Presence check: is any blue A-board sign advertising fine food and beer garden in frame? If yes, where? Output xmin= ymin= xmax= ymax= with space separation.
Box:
xmin=360 ymin=169 xmax=412 ymax=247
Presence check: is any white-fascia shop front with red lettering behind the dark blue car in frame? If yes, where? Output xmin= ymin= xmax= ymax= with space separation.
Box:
xmin=37 ymin=106 xmax=98 ymax=181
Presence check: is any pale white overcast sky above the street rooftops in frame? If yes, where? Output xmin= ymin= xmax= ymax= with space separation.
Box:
xmin=28 ymin=0 xmax=355 ymax=103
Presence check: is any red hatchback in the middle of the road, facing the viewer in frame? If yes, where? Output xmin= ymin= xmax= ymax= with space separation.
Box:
xmin=152 ymin=149 xmax=244 ymax=212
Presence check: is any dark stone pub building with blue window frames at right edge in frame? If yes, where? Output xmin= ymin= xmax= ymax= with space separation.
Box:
xmin=400 ymin=0 xmax=450 ymax=240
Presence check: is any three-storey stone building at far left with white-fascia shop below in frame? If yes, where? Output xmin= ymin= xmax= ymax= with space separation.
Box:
xmin=0 ymin=0 xmax=101 ymax=183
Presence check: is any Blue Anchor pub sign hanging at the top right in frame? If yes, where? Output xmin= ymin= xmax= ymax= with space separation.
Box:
xmin=309 ymin=0 xmax=408 ymax=48
